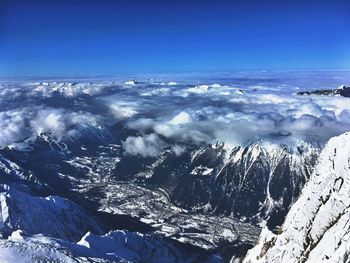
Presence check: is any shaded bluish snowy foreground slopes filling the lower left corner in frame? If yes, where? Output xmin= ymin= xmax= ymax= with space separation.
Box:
xmin=0 ymin=184 xmax=222 ymax=263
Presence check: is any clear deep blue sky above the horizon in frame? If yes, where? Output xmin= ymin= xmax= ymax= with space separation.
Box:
xmin=0 ymin=0 xmax=350 ymax=76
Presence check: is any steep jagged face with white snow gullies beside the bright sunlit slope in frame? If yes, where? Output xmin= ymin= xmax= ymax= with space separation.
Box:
xmin=211 ymin=143 xmax=317 ymax=227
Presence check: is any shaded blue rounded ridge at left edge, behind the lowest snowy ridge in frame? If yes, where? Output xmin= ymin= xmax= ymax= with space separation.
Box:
xmin=0 ymin=185 xmax=102 ymax=241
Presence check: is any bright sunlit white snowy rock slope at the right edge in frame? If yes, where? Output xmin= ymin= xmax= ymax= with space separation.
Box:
xmin=244 ymin=132 xmax=350 ymax=263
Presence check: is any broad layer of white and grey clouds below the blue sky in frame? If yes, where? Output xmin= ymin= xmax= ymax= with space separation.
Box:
xmin=0 ymin=73 xmax=350 ymax=157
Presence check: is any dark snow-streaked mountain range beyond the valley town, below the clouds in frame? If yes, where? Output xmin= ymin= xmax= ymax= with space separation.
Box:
xmin=0 ymin=128 xmax=320 ymax=231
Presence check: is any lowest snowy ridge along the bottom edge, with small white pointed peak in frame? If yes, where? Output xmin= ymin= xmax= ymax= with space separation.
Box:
xmin=0 ymin=230 xmax=221 ymax=263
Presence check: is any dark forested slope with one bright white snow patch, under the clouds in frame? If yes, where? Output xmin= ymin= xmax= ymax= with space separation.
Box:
xmin=149 ymin=144 xmax=226 ymax=209
